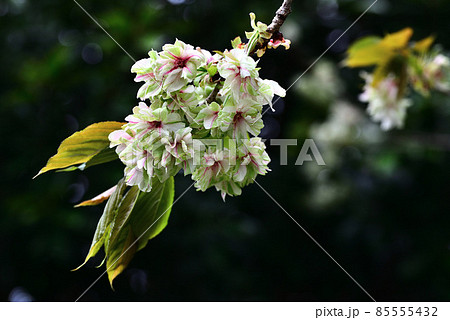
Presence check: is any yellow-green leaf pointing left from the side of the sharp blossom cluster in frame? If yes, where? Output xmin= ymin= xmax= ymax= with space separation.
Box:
xmin=35 ymin=121 xmax=124 ymax=177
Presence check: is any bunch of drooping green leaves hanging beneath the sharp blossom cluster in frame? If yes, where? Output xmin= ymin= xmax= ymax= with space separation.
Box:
xmin=75 ymin=177 xmax=174 ymax=287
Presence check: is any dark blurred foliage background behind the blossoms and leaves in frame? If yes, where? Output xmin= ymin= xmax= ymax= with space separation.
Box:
xmin=0 ymin=0 xmax=450 ymax=301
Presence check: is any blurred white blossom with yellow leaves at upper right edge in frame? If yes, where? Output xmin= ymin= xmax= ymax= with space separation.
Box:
xmin=344 ymin=28 xmax=450 ymax=130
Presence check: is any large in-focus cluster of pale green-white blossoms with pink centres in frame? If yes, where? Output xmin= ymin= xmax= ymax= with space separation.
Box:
xmin=109 ymin=40 xmax=285 ymax=198
